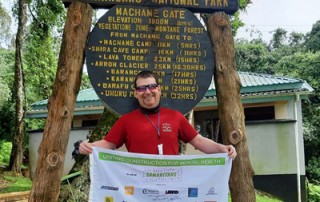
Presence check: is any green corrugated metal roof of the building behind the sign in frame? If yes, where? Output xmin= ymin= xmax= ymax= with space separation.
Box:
xmin=27 ymin=72 xmax=314 ymax=118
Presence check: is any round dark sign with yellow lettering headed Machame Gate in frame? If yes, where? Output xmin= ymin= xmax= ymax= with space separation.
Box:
xmin=86 ymin=5 xmax=214 ymax=115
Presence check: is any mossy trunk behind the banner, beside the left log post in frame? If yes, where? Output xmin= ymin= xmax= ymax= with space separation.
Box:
xmin=59 ymin=109 xmax=117 ymax=202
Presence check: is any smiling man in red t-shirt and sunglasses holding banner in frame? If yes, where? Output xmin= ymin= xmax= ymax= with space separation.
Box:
xmin=79 ymin=71 xmax=237 ymax=159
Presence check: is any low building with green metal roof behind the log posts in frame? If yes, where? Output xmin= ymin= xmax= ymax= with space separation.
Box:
xmin=27 ymin=72 xmax=313 ymax=201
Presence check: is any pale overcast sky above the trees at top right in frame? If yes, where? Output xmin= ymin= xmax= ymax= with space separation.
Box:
xmin=236 ymin=0 xmax=320 ymax=41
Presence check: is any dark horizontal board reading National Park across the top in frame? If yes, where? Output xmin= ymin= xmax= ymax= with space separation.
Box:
xmin=62 ymin=0 xmax=238 ymax=14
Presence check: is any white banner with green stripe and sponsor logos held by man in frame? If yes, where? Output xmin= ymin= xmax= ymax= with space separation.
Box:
xmin=89 ymin=148 xmax=232 ymax=202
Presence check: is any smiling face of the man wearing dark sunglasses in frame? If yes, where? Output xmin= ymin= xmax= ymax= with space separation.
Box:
xmin=134 ymin=77 xmax=161 ymax=109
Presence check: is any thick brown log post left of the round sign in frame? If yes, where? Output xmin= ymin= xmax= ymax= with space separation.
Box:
xmin=29 ymin=1 xmax=92 ymax=202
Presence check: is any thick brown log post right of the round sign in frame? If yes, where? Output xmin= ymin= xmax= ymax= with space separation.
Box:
xmin=207 ymin=13 xmax=256 ymax=202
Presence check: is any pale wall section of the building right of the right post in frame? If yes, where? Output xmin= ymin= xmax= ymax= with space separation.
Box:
xmin=246 ymin=122 xmax=297 ymax=175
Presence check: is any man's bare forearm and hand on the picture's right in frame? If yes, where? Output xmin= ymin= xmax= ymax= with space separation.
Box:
xmin=189 ymin=135 xmax=237 ymax=159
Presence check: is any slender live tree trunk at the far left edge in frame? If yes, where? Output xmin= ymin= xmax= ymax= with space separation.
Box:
xmin=9 ymin=0 xmax=27 ymax=173
